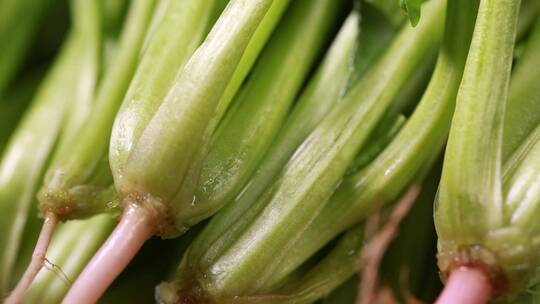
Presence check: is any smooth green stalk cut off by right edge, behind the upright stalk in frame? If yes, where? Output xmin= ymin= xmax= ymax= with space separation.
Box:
xmin=502 ymin=18 xmax=540 ymax=161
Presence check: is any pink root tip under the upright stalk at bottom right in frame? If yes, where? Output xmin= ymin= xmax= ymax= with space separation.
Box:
xmin=436 ymin=266 xmax=493 ymax=304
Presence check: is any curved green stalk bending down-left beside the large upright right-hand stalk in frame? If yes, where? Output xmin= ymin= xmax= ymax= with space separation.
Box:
xmin=268 ymin=0 xmax=476 ymax=280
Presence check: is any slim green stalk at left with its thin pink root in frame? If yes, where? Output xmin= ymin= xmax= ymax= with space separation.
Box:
xmin=6 ymin=1 xmax=154 ymax=300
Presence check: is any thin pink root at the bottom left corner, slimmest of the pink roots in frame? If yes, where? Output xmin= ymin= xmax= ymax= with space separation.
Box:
xmin=4 ymin=213 xmax=58 ymax=304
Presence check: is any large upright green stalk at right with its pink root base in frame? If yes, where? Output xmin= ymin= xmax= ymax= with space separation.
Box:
xmin=435 ymin=0 xmax=539 ymax=303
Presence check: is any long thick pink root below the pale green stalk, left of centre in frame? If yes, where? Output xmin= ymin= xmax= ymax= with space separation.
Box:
xmin=62 ymin=204 xmax=153 ymax=304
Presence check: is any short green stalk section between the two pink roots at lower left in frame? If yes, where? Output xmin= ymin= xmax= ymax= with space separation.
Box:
xmin=24 ymin=214 xmax=116 ymax=303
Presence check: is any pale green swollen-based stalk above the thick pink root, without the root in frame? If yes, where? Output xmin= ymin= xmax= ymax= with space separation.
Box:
xmin=110 ymin=0 xmax=273 ymax=237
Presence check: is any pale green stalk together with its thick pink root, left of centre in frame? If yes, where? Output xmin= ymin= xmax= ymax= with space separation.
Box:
xmin=64 ymin=0 xmax=280 ymax=303
